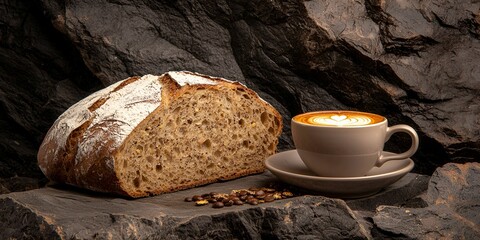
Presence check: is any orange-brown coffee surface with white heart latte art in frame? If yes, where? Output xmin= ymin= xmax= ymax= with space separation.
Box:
xmin=293 ymin=111 xmax=385 ymax=127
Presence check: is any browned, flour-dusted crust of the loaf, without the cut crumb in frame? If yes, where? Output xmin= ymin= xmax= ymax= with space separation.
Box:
xmin=38 ymin=72 xmax=282 ymax=197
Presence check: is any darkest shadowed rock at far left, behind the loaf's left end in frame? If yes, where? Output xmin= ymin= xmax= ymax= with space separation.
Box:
xmin=0 ymin=1 xmax=101 ymax=182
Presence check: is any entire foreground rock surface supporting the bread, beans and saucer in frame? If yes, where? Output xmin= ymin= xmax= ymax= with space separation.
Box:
xmin=0 ymin=163 xmax=480 ymax=239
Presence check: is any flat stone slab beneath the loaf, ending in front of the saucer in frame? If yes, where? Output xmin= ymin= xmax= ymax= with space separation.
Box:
xmin=0 ymin=173 xmax=368 ymax=239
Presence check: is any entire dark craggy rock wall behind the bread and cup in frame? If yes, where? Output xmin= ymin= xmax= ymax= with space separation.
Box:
xmin=0 ymin=0 xmax=480 ymax=193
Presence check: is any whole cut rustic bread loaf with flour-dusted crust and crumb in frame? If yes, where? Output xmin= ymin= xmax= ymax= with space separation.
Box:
xmin=38 ymin=72 xmax=282 ymax=197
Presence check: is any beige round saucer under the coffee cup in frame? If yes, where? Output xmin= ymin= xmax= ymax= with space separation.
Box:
xmin=265 ymin=150 xmax=414 ymax=198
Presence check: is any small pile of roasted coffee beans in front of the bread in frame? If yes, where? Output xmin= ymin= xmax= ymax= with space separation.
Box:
xmin=185 ymin=187 xmax=294 ymax=208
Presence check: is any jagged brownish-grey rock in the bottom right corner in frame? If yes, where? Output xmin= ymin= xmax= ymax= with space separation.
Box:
xmin=373 ymin=163 xmax=480 ymax=239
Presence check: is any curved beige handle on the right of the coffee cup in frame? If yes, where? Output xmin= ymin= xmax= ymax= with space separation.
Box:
xmin=375 ymin=124 xmax=419 ymax=167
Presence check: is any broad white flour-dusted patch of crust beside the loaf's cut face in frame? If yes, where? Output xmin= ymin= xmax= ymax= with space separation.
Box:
xmin=75 ymin=75 xmax=162 ymax=164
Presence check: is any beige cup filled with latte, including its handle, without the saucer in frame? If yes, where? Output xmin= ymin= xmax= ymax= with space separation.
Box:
xmin=291 ymin=111 xmax=419 ymax=177
